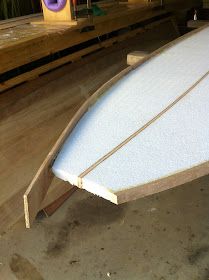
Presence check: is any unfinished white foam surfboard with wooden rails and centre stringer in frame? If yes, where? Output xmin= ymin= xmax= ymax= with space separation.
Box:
xmin=24 ymin=26 xmax=209 ymax=227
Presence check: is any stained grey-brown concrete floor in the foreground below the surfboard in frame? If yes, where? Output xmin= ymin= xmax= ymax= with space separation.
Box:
xmin=0 ymin=20 xmax=209 ymax=280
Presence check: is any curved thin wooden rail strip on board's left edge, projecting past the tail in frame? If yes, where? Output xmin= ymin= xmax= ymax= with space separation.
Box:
xmin=24 ymin=25 xmax=206 ymax=228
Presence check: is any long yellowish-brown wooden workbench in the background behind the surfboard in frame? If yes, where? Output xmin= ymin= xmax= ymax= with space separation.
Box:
xmin=0 ymin=3 xmax=170 ymax=91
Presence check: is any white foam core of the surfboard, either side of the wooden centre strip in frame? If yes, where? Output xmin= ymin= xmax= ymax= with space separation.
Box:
xmin=53 ymin=27 xmax=209 ymax=196
